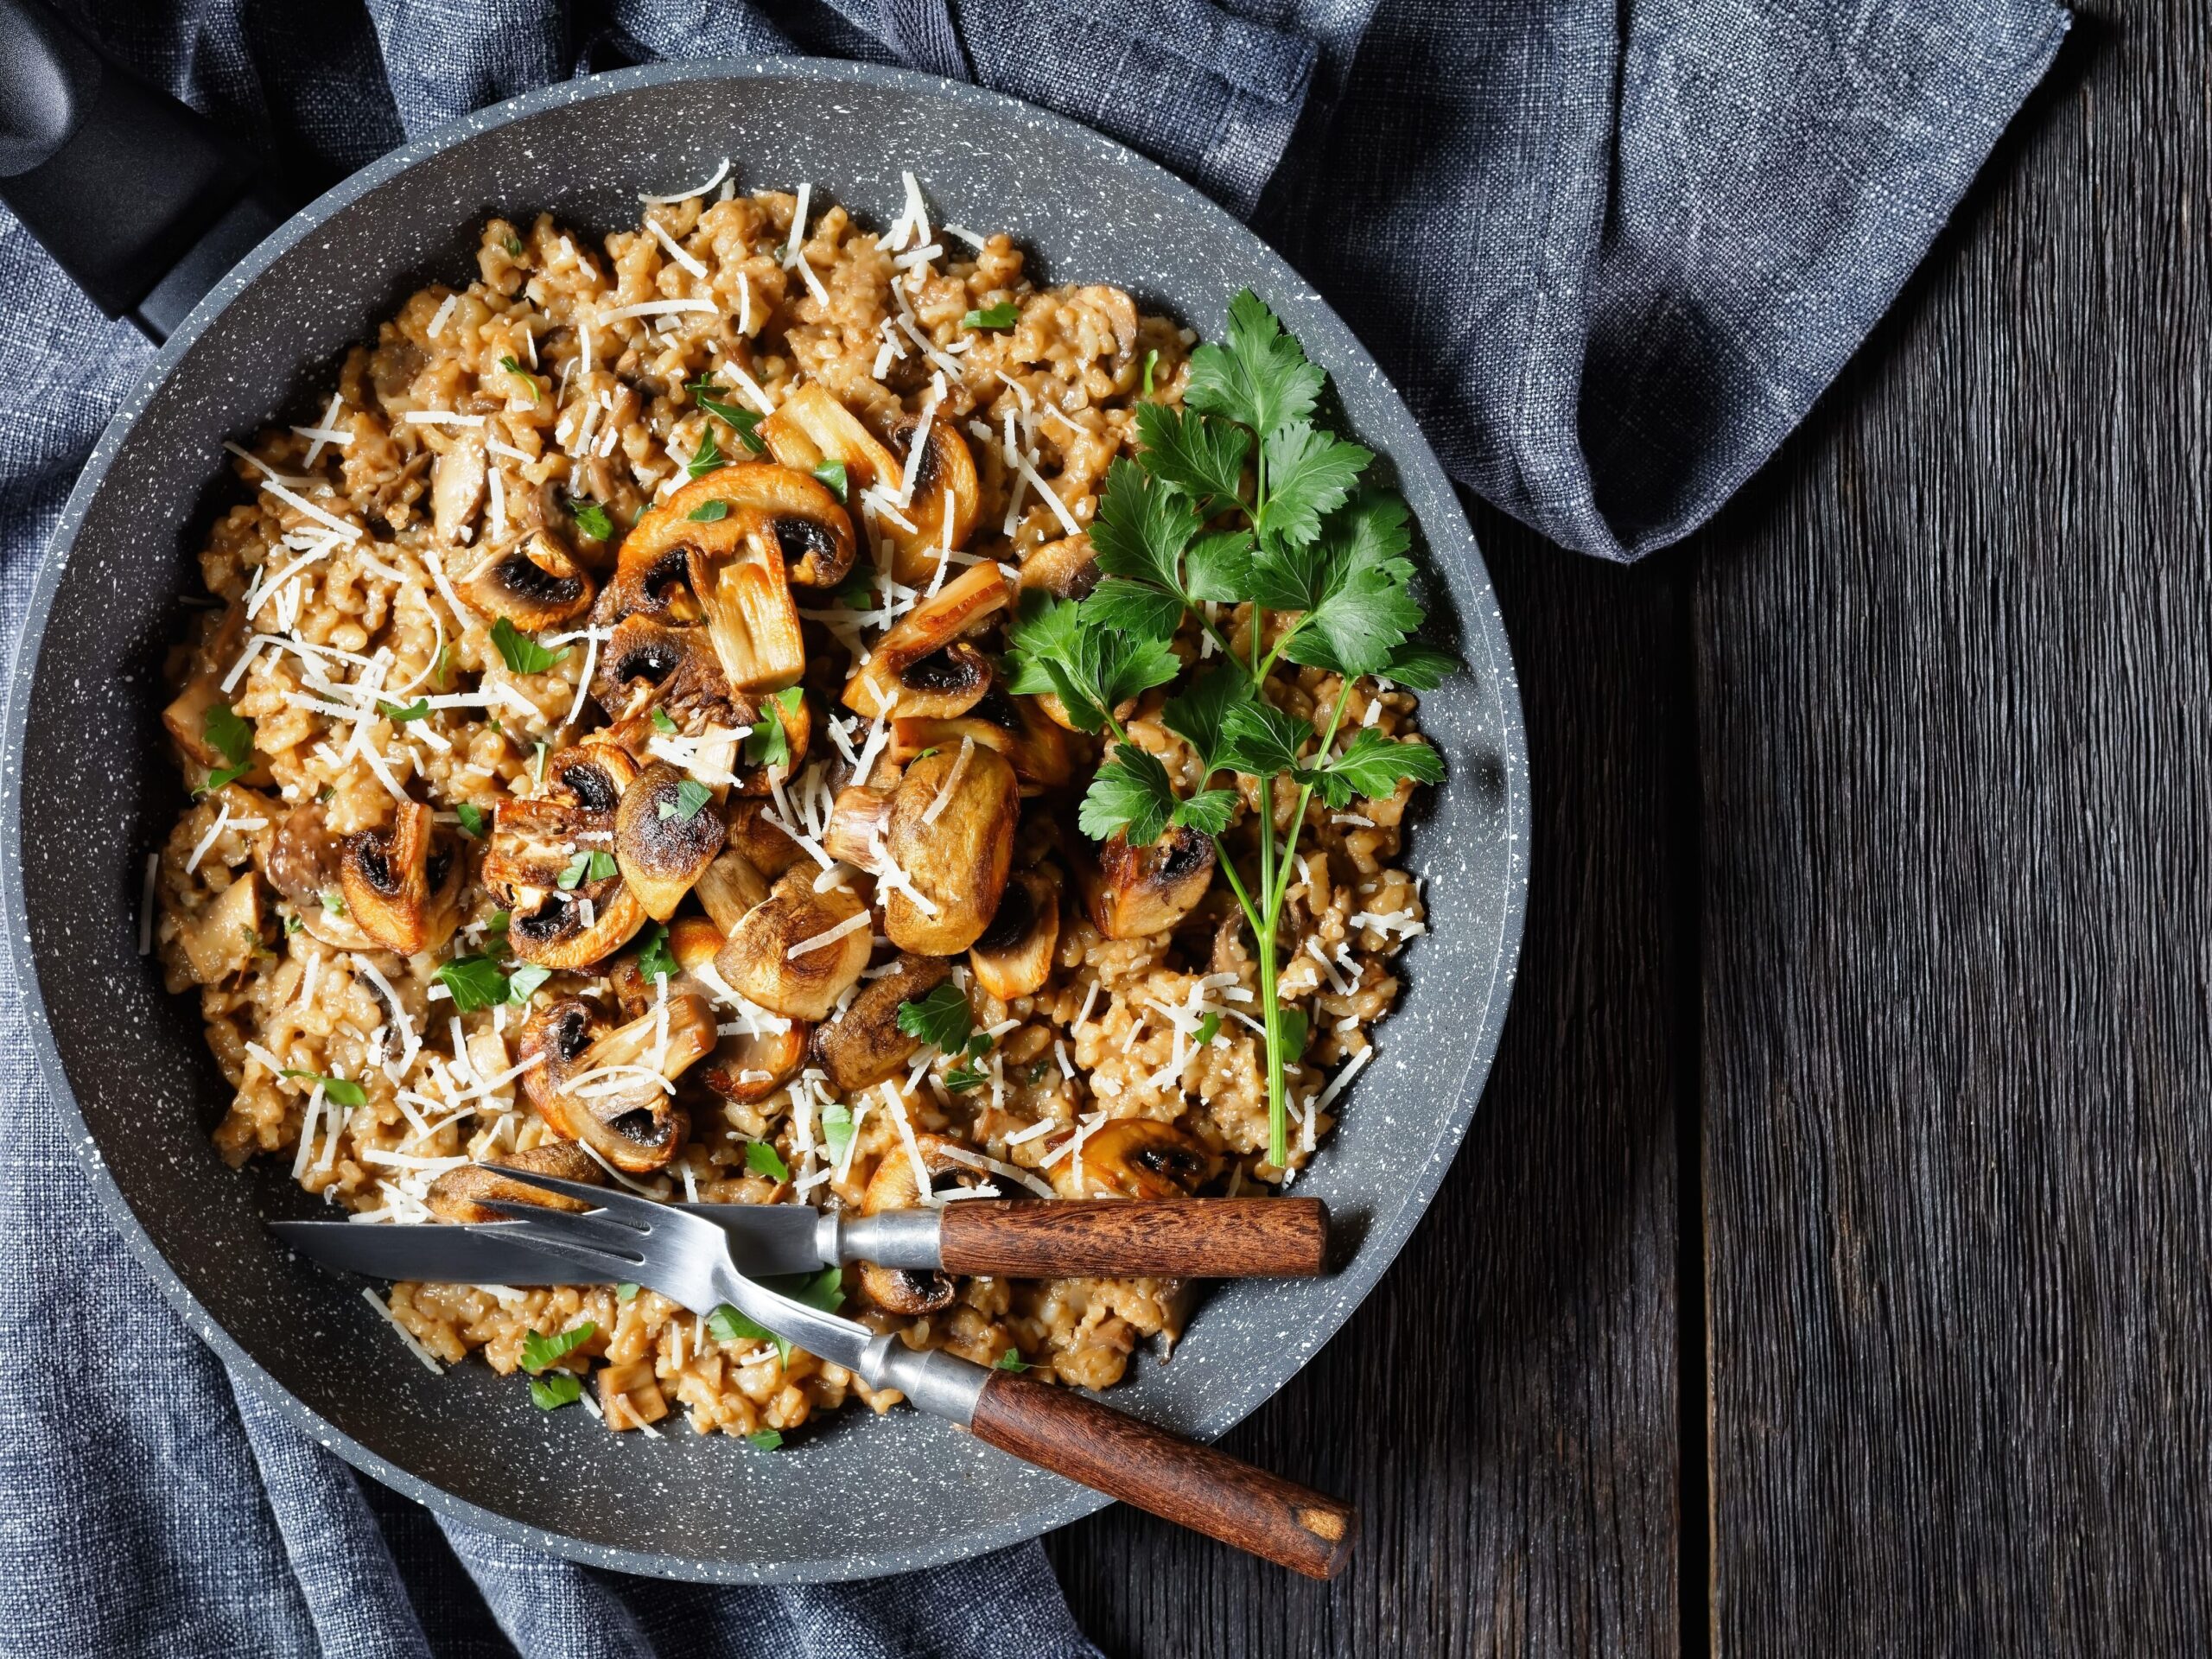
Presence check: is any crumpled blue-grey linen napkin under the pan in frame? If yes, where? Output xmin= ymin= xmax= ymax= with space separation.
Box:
xmin=0 ymin=0 xmax=2066 ymax=1659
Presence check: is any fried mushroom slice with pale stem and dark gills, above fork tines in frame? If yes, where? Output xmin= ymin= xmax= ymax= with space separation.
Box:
xmin=520 ymin=995 xmax=715 ymax=1174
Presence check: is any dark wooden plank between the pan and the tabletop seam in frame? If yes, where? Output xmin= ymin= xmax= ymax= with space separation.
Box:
xmin=1048 ymin=513 xmax=1701 ymax=1659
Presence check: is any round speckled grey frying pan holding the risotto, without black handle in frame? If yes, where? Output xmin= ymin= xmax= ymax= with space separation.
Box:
xmin=0 ymin=60 xmax=1529 ymax=1581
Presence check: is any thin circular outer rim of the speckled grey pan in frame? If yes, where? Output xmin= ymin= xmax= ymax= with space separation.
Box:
xmin=0 ymin=55 xmax=1531 ymax=1584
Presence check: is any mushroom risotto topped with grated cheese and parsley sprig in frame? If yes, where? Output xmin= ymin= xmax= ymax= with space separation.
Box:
xmin=139 ymin=175 xmax=1451 ymax=1445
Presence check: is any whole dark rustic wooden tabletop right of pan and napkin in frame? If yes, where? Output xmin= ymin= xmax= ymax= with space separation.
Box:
xmin=1048 ymin=0 xmax=2212 ymax=1659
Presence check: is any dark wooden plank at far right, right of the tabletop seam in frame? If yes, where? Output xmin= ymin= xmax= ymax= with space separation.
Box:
xmin=1697 ymin=4 xmax=2212 ymax=1655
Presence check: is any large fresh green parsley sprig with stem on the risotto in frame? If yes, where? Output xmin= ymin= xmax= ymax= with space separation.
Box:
xmin=1008 ymin=289 xmax=1458 ymax=1166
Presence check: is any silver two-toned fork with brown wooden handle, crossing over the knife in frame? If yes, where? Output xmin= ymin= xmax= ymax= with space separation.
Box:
xmin=485 ymin=1168 xmax=1358 ymax=1580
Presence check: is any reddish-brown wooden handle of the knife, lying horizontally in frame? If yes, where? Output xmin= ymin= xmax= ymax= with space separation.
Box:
xmin=938 ymin=1199 xmax=1330 ymax=1279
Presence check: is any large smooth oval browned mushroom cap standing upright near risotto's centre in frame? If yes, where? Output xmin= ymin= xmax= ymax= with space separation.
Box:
xmin=878 ymin=743 xmax=1022 ymax=956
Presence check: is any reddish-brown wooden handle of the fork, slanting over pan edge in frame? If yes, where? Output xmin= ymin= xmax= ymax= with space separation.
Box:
xmin=969 ymin=1380 xmax=1360 ymax=1580
